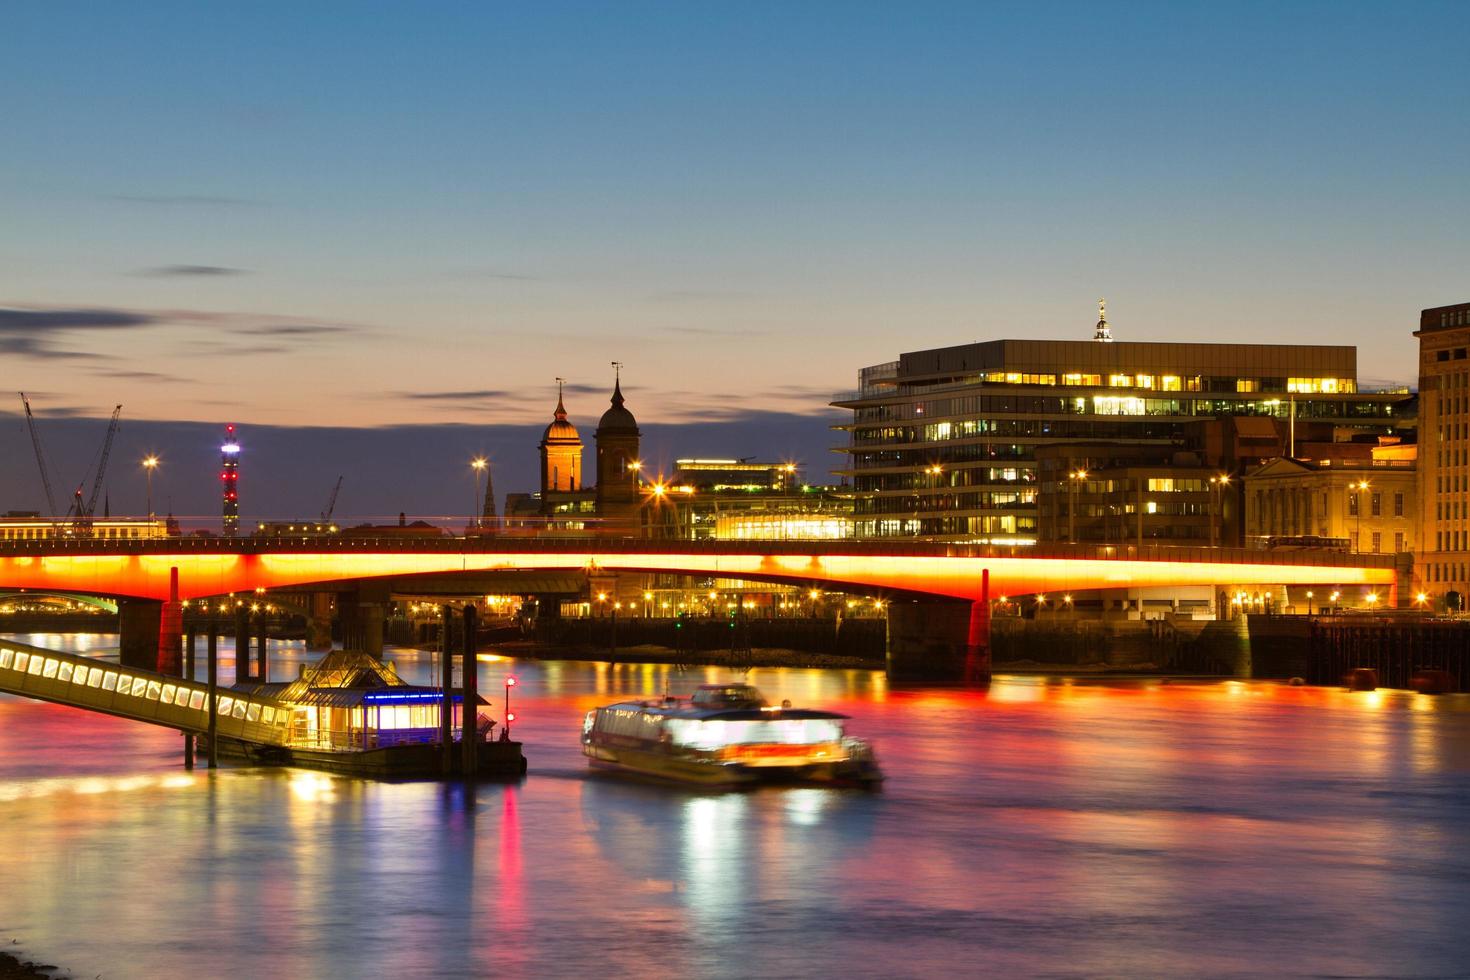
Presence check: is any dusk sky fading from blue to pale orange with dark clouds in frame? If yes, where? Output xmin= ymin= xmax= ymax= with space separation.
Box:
xmin=0 ymin=0 xmax=1470 ymax=516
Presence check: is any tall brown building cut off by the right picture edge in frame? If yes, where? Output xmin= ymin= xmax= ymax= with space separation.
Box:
xmin=1414 ymin=303 xmax=1470 ymax=608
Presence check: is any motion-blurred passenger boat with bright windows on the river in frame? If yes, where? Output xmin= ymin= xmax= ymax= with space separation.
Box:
xmin=582 ymin=685 xmax=883 ymax=786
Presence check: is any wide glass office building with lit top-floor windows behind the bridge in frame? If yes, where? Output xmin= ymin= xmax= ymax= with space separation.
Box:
xmin=832 ymin=312 xmax=1410 ymax=545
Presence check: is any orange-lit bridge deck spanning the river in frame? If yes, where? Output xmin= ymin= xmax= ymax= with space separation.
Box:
xmin=0 ymin=538 xmax=1397 ymax=602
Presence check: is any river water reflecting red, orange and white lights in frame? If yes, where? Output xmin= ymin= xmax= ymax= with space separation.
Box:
xmin=0 ymin=636 xmax=1470 ymax=977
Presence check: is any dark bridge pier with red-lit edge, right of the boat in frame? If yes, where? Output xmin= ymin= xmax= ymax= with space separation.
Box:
xmin=888 ymin=601 xmax=991 ymax=685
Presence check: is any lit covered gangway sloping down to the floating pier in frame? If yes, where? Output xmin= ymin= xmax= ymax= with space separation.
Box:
xmin=0 ymin=641 xmax=291 ymax=745
